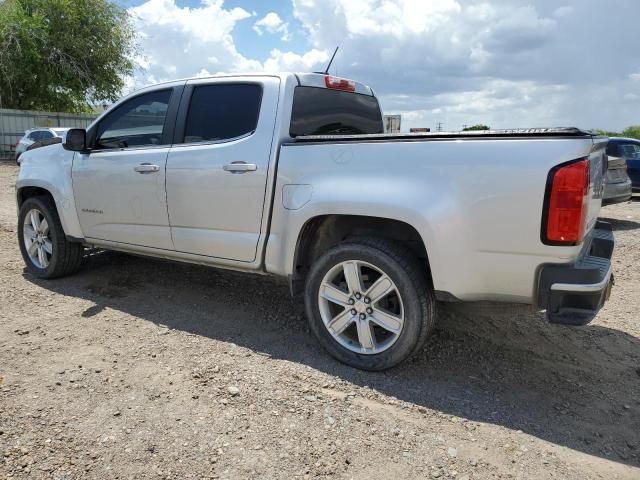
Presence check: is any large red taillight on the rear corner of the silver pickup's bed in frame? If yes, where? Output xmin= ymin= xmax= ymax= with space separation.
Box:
xmin=542 ymin=158 xmax=590 ymax=245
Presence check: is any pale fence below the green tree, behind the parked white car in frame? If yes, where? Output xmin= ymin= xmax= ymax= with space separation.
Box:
xmin=0 ymin=108 xmax=97 ymax=158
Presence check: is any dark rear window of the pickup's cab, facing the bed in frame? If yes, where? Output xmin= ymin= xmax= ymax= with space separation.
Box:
xmin=289 ymin=87 xmax=384 ymax=137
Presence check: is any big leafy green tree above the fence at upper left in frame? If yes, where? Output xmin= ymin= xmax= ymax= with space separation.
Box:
xmin=0 ymin=0 xmax=136 ymax=112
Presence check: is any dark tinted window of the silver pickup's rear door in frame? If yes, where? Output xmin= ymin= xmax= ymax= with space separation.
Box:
xmin=183 ymin=83 xmax=262 ymax=143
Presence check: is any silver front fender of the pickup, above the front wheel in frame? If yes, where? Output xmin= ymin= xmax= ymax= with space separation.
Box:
xmin=16 ymin=144 xmax=84 ymax=238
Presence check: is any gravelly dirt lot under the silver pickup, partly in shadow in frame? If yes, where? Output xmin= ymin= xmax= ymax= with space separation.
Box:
xmin=0 ymin=162 xmax=640 ymax=480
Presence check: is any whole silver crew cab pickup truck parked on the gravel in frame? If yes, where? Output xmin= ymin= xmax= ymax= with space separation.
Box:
xmin=17 ymin=73 xmax=614 ymax=370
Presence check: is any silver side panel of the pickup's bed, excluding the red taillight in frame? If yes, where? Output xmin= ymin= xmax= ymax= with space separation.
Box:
xmin=267 ymin=128 xmax=606 ymax=303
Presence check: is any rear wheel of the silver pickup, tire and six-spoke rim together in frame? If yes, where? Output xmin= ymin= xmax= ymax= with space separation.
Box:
xmin=305 ymin=239 xmax=436 ymax=370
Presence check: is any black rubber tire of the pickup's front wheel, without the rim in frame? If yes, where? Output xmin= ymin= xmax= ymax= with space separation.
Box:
xmin=18 ymin=196 xmax=84 ymax=278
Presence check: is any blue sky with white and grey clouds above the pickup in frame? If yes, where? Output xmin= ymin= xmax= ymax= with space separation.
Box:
xmin=120 ymin=0 xmax=640 ymax=131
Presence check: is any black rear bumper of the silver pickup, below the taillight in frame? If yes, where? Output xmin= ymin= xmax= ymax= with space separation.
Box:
xmin=538 ymin=221 xmax=615 ymax=325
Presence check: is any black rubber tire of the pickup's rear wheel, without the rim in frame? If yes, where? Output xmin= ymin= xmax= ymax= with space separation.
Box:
xmin=304 ymin=238 xmax=436 ymax=371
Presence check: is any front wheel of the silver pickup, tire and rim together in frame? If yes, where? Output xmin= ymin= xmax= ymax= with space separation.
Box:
xmin=18 ymin=196 xmax=84 ymax=278
